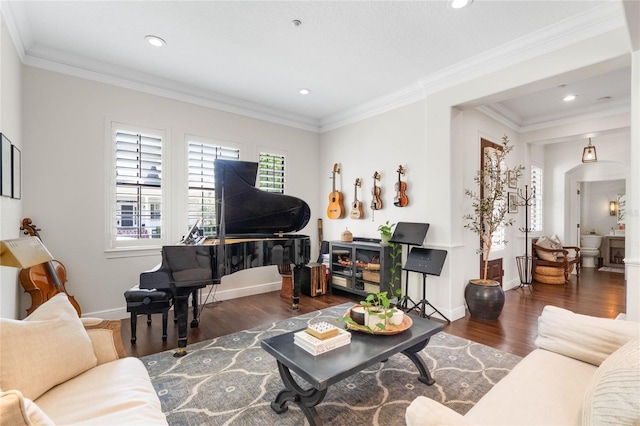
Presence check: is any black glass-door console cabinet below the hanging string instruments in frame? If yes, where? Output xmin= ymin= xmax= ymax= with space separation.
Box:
xmin=329 ymin=241 xmax=401 ymax=297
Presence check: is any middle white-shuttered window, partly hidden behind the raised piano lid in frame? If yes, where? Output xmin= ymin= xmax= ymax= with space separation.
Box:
xmin=187 ymin=140 xmax=240 ymax=235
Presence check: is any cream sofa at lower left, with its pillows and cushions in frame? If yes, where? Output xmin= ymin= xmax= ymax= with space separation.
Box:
xmin=0 ymin=293 xmax=167 ymax=426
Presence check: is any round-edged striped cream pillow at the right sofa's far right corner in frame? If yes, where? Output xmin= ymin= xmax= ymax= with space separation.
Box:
xmin=582 ymin=339 xmax=640 ymax=425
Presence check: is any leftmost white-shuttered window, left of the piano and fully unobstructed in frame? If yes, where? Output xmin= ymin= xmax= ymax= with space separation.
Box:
xmin=111 ymin=128 xmax=162 ymax=247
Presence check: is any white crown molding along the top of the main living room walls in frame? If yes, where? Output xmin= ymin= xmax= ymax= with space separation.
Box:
xmin=0 ymin=1 xmax=626 ymax=133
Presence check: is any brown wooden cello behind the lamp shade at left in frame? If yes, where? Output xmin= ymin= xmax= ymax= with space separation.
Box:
xmin=20 ymin=217 xmax=82 ymax=316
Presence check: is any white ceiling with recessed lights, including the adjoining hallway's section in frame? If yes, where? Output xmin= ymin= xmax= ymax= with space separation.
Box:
xmin=2 ymin=0 xmax=631 ymax=131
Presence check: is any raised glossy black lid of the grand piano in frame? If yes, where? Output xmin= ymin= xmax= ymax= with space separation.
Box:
xmin=214 ymin=159 xmax=311 ymax=235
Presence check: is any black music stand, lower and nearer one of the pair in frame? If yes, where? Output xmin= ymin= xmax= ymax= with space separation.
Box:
xmin=402 ymin=247 xmax=451 ymax=324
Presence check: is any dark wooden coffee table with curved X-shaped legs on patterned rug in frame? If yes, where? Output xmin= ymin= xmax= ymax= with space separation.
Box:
xmin=260 ymin=315 xmax=444 ymax=426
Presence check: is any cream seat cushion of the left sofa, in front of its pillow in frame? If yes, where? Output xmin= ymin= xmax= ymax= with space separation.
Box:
xmin=35 ymin=357 xmax=167 ymax=426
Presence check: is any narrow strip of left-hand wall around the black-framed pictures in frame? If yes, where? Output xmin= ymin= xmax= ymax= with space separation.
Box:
xmin=0 ymin=16 xmax=24 ymax=318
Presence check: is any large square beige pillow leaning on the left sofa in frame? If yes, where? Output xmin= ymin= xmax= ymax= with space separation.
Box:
xmin=0 ymin=293 xmax=97 ymax=400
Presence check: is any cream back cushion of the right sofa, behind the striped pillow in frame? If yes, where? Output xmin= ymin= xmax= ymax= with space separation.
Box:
xmin=535 ymin=306 xmax=640 ymax=366
